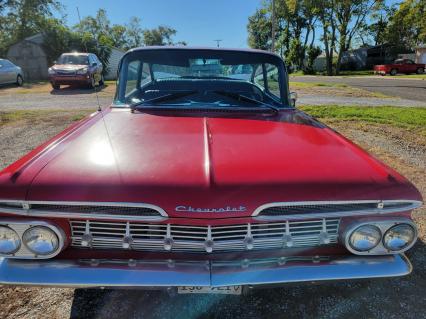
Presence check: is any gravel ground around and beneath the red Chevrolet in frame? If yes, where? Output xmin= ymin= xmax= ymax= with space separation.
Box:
xmin=0 ymin=113 xmax=426 ymax=319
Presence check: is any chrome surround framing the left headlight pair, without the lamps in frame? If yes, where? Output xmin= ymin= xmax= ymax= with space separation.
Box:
xmin=0 ymin=219 xmax=65 ymax=259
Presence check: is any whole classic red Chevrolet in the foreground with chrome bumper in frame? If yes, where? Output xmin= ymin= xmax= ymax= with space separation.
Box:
xmin=0 ymin=47 xmax=422 ymax=294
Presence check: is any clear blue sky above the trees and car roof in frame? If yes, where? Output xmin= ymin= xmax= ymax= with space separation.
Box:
xmin=57 ymin=0 xmax=262 ymax=48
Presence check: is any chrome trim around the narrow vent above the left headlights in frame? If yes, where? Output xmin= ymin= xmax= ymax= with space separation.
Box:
xmin=0 ymin=200 xmax=168 ymax=221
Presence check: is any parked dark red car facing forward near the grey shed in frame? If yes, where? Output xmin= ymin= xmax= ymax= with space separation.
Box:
xmin=48 ymin=53 xmax=104 ymax=90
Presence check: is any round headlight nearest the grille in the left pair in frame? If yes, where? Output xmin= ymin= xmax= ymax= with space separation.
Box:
xmin=22 ymin=226 xmax=59 ymax=255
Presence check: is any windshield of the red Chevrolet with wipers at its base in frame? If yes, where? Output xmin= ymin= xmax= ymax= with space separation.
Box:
xmin=114 ymin=49 xmax=288 ymax=108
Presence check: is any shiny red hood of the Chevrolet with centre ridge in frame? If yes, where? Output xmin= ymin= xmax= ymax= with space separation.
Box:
xmin=3 ymin=109 xmax=419 ymax=218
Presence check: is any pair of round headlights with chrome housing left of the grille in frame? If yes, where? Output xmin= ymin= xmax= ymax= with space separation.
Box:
xmin=0 ymin=222 xmax=64 ymax=258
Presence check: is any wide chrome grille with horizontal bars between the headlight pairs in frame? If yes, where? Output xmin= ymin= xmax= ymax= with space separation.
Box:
xmin=70 ymin=218 xmax=339 ymax=252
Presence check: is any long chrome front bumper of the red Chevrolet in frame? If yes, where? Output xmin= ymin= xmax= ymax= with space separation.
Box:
xmin=0 ymin=254 xmax=412 ymax=287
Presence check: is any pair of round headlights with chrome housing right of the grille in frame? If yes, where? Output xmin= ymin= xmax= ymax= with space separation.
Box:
xmin=344 ymin=220 xmax=417 ymax=255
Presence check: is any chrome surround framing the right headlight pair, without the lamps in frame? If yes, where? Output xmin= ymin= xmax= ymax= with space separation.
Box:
xmin=341 ymin=218 xmax=418 ymax=256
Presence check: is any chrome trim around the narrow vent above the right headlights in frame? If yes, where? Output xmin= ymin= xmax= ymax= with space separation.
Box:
xmin=252 ymin=199 xmax=423 ymax=221
